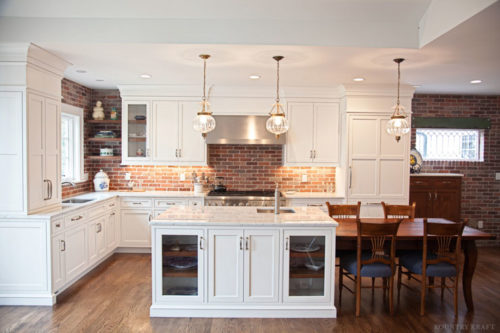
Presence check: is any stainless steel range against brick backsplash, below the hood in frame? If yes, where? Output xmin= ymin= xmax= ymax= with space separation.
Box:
xmin=205 ymin=191 xmax=285 ymax=207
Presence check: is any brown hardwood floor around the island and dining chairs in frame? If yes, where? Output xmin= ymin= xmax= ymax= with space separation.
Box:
xmin=0 ymin=248 xmax=500 ymax=333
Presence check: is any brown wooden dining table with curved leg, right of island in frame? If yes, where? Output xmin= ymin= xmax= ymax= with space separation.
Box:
xmin=335 ymin=218 xmax=496 ymax=311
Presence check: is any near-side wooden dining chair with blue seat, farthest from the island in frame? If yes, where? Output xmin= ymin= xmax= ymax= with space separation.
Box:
xmin=398 ymin=219 xmax=468 ymax=316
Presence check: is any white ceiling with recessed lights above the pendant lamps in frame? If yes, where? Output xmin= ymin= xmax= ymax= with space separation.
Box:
xmin=0 ymin=0 xmax=500 ymax=94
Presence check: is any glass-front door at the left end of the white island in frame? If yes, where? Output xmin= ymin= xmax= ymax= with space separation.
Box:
xmin=153 ymin=229 xmax=206 ymax=304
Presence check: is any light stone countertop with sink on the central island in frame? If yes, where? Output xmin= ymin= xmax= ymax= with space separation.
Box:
xmin=150 ymin=206 xmax=338 ymax=227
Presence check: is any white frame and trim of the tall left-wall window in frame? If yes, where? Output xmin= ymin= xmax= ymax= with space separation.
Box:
xmin=60 ymin=103 xmax=87 ymax=183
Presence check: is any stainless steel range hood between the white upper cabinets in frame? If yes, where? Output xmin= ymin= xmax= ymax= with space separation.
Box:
xmin=206 ymin=116 xmax=285 ymax=145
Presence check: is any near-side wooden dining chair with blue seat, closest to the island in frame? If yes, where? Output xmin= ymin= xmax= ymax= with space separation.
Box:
xmin=339 ymin=219 xmax=402 ymax=317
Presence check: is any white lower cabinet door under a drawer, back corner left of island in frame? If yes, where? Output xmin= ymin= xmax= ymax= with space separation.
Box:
xmin=120 ymin=209 xmax=153 ymax=247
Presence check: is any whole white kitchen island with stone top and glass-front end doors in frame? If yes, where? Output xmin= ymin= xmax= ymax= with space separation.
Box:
xmin=150 ymin=206 xmax=338 ymax=318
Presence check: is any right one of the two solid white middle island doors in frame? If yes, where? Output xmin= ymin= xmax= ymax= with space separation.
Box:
xmin=244 ymin=229 xmax=280 ymax=303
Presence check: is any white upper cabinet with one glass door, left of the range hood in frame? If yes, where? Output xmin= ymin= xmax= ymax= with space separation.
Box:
xmin=122 ymin=100 xmax=207 ymax=165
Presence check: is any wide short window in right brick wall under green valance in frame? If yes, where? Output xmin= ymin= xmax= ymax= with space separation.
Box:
xmin=416 ymin=128 xmax=484 ymax=161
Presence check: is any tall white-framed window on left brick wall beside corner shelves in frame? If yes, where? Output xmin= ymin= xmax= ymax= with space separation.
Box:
xmin=61 ymin=104 xmax=84 ymax=182
